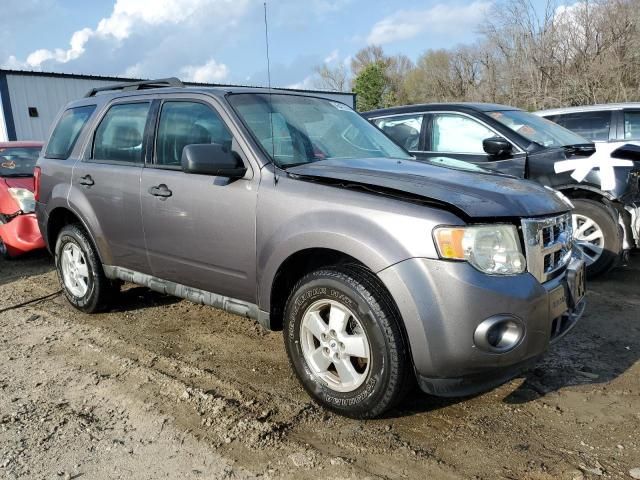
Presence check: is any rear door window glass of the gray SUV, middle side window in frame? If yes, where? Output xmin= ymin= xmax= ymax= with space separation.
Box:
xmin=93 ymin=102 xmax=151 ymax=164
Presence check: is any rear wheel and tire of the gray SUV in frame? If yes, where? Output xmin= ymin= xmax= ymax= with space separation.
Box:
xmin=55 ymin=225 xmax=117 ymax=313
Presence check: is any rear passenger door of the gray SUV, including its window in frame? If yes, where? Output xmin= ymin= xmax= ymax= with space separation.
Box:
xmin=72 ymin=97 xmax=151 ymax=273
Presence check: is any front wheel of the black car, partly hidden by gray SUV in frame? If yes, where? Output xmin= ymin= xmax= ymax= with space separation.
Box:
xmin=572 ymin=198 xmax=622 ymax=278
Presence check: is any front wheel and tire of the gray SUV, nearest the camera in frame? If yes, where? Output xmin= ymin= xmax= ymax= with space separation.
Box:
xmin=283 ymin=267 xmax=413 ymax=418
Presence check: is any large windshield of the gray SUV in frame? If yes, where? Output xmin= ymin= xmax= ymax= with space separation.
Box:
xmin=229 ymin=93 xmax=412 ymax=168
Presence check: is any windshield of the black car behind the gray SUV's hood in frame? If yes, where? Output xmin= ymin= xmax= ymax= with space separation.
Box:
xmin=488 ymin=110 xmax=590 ymax=147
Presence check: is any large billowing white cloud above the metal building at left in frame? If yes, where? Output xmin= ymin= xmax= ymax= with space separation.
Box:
xmin=5 ymin=0 xmax=250 ymax=77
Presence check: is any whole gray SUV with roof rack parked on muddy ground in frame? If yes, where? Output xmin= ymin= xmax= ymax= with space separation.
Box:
xmin=36 ymin=80 xmax=584 ymax=418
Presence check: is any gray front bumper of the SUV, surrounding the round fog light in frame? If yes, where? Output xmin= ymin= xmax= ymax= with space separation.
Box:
xmin=378 ymin=258 xmax=584 ymax=396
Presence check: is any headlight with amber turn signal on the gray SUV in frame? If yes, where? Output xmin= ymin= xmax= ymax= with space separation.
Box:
xmin=434 ymin=225 xmax=526 ymax=275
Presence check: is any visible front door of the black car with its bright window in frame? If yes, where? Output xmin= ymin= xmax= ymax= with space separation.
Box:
xmin=417 ymin=112 xmax=527 ymax=178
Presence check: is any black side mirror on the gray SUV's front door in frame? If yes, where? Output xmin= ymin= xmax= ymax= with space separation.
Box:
xmin=181 ymin=143 xmax=247 ymax=178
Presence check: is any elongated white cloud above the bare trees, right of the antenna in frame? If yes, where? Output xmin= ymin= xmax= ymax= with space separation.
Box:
xmin=367 ymin=0 xmax=491 ymax=45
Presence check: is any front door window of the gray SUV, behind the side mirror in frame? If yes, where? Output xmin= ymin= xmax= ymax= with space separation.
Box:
xmin=156 ymin=101 xmax=233 ymax=168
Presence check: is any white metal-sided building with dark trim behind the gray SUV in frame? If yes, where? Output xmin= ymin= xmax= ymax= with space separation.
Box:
xmin=0 ymin=70 xmax=355 ymax=142
